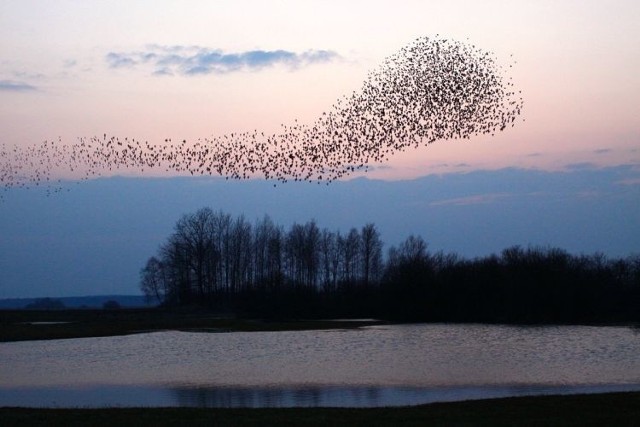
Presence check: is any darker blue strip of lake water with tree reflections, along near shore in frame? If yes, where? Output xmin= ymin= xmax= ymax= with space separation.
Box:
xmin=0 ymin=384 xmax=640 ymax=408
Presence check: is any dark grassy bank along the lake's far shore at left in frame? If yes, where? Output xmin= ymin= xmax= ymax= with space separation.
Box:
xmin=0 ymin=309 xmax=380 ymax=342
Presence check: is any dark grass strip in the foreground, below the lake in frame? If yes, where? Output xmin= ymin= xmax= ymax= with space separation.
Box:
xmin=0 ymin=392 xmax=640 ymax=427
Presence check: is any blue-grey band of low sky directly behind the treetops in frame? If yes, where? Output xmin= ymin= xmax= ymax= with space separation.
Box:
xmin=0 ymin=165 xmax=640 ymax=298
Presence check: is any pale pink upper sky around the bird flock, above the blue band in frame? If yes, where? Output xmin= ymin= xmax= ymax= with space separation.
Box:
xmin=0 ymin=0 xmax=640 ymax=179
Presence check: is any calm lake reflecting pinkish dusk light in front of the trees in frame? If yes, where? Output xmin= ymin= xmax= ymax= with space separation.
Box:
xmin=0 ymin=324 xmax=640 ymax=407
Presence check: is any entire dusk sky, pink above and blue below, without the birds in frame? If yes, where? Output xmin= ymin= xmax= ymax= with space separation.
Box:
xmin=0 ymin=0 xmax=640 ymax=298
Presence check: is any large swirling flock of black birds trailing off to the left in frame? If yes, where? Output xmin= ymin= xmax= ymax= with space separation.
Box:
xmin=0 ymin=36 xmax=523 ymax=197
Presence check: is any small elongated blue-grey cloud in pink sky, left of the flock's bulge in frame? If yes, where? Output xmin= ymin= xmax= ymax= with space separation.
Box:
xmin=105 ymin=45 xmax=340 ymax=76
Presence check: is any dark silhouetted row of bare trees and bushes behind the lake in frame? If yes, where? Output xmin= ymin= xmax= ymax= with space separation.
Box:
xmin=140 ymin=208 xmax=640 ymax=323
